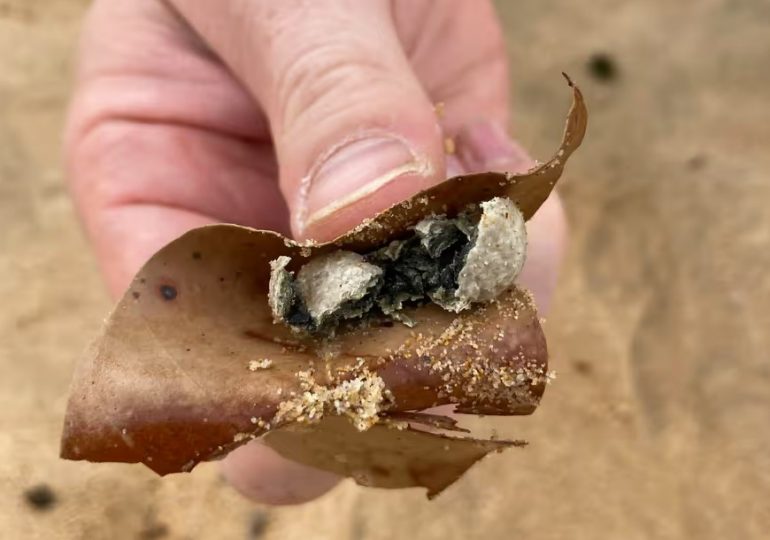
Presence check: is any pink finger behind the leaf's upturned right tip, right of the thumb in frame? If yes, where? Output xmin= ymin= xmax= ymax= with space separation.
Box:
xmin=457 ymin=122 xmax=567 ymax=314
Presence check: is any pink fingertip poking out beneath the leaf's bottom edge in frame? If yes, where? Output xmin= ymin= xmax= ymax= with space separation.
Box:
xmin=221 ymin=441 xmax=340 ymax=505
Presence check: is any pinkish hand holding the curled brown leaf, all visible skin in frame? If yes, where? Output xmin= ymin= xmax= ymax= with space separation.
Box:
xmin=65 ymin=0 xmax=566 ymax=504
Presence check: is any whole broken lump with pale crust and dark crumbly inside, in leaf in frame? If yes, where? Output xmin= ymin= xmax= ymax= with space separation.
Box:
xmin=269 ymin=197 xmax=527 ymax=333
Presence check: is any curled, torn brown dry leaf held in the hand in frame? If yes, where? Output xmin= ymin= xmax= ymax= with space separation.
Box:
xmin=61 ymin=77 xmax=586 ymax=493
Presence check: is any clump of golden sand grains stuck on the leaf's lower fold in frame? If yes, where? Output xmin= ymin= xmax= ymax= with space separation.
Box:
xmin=271 ymin=362 xmax=392 ymax=431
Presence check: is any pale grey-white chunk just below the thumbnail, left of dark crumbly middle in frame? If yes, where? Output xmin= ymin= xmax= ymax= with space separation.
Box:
xmin=294 ymin=251 xmax=382 ymax=325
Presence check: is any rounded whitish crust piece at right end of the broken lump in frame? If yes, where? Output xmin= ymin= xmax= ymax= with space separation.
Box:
xmin=452 ymin=197 xmax=527 ymax=311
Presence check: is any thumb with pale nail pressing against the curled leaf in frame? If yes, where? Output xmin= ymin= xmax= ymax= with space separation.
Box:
xmin=170 ymin=0 xmax=445 ymax=240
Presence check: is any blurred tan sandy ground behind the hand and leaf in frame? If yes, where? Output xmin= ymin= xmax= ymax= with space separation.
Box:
xmin=0 ymin=0 xmax=770 ymax=540
